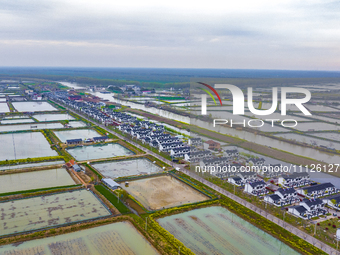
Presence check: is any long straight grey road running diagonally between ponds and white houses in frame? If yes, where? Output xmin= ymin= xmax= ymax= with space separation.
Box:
xmin=64 ymin=104 xmax=337 ymax=254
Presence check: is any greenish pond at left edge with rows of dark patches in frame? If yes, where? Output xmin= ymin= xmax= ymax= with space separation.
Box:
xmin=0 ymin=190 xmax=111 ymax=236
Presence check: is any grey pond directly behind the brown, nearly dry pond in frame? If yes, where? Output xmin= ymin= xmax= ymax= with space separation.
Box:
xmin=91 ymin=158 xmax=162 ymax=179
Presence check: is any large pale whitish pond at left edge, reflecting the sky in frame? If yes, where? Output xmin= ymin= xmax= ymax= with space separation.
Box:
xmin=0 ymin=132 xmax=58 ymax=161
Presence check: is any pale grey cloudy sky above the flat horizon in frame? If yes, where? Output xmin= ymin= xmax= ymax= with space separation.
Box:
xmin=0 ymin=0 xmax=340 ymax=71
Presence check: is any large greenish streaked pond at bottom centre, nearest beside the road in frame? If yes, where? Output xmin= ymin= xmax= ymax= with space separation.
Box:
xmin=157 ymin=206 xmax=299 ymax=255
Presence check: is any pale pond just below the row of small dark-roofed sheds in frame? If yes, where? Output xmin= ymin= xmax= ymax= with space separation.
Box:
xmin=67 ymin=143 xmax=135 ymax=160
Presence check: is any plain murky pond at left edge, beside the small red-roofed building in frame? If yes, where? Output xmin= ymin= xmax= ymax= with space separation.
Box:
xmin=0 ymin=168 xmax=76 ymax=194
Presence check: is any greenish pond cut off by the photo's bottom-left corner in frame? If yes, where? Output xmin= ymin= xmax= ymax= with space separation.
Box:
xmin=0 ymin=222 xmax=159 ymax=255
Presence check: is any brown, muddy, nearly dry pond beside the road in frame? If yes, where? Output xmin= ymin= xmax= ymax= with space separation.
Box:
xmin=122 ymin=176 xmax=209 ymax=211
